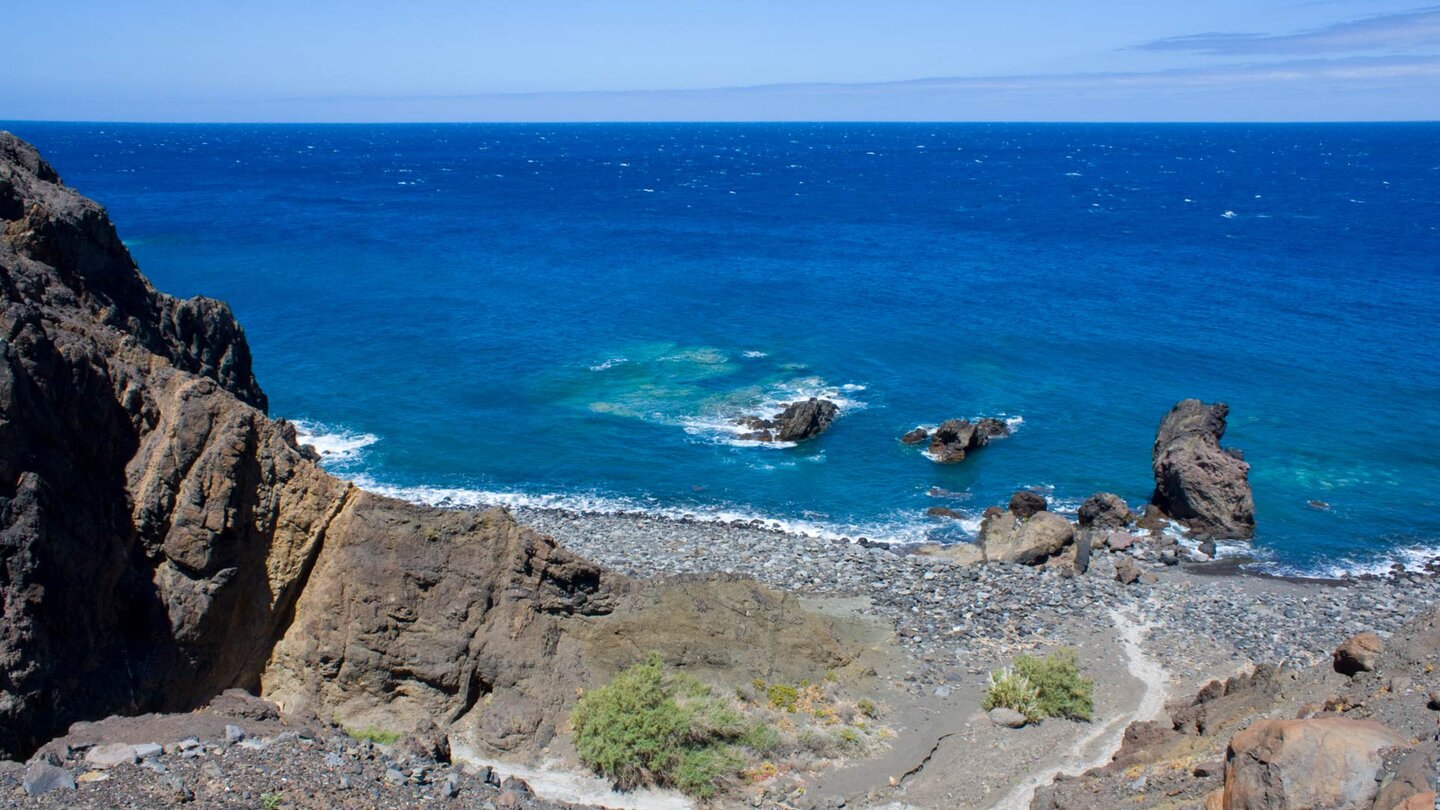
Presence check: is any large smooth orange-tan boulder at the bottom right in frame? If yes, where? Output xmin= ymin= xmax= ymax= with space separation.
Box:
xmin=1224 ymin=718 xmax=1405 ymax=810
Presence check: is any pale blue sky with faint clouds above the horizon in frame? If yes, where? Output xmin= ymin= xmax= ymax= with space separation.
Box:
xmin=0 ymin=0 xmax=1440 ymax=121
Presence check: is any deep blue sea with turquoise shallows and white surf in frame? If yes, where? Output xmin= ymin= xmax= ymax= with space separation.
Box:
xmin=11 ymin=123 xmax=1440 ymax=574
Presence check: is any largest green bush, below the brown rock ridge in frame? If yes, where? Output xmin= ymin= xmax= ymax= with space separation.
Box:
xmin=570 ymin=653 xmax=756 ymax=798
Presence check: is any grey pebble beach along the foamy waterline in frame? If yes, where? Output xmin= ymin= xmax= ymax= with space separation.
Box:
xmin=514 ymin=509 xmax=1440 ymax=686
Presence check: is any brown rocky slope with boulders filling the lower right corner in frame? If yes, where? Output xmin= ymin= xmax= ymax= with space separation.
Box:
xmin=1031 ymin=611 xmax=1440 ymax=810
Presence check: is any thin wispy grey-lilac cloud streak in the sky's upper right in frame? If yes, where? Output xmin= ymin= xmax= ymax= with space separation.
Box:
xmin=1136 ymin=6 xmax=1440 ymax=56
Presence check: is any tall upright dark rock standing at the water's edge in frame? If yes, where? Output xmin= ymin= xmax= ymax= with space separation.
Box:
xmin=1151 ymin=399 xmax=1256 ymax=539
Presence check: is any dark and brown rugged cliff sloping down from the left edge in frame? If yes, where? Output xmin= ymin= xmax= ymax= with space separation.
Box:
xmin=0 ymin=133 xmax=619 ymax=755
